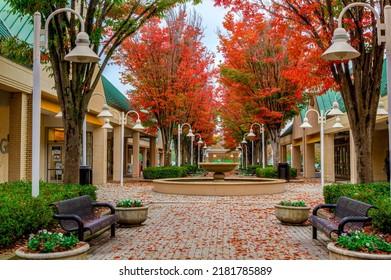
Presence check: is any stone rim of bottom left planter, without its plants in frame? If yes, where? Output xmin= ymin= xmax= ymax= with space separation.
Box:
xmin=15 ymin=242 xmax=90 ymax=260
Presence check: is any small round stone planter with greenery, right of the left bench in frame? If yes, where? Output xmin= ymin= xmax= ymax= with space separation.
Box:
xmin=115 ymin=199 xmax=149 ymax=226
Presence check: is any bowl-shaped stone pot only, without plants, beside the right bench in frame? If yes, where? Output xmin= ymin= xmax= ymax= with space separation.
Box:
xmin=274 ymin=205 xmax=311 ymax=224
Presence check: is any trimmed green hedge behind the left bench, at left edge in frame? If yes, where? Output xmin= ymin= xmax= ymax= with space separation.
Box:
xmin=0 ymin=181 xmax=96 ymax=246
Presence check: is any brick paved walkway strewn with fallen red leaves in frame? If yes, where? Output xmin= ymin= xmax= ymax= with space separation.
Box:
xmin=89 ymin=179 xmax=328 ymax=260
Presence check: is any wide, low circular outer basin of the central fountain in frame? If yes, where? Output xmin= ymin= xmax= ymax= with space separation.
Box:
xmin=153 ymin=178 xmax=286 ymax=196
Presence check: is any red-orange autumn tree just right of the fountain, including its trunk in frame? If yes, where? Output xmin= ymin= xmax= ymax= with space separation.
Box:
xmin=220 ymin=3 xmax=311 ymax=164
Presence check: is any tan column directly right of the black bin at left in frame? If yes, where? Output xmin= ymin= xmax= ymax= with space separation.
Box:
xmin=92 ymin=127 xmax=107 ymax=185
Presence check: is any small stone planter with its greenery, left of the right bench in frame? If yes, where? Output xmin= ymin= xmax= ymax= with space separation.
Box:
xmin=274 ymin=201 xmax=311 ymax=224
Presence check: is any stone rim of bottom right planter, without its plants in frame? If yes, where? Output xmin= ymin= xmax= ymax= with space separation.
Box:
xmin=327 ymin=242 xmax=391 ymax=260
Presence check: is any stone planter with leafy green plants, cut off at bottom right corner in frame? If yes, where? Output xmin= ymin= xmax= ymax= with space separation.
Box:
xmin=327 ymin=231 xmax=391 ymax=260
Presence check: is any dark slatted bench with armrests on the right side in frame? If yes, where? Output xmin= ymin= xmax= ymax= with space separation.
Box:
xmin=309 ymin=196 xmax=376 ymax=239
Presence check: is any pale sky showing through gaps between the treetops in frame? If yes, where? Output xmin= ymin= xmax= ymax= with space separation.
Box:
xmin=103 ymin=0 xmax=225 ymax=94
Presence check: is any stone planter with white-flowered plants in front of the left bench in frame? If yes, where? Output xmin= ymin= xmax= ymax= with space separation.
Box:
xmin=15 ymin=229 xmax=90 ymax=260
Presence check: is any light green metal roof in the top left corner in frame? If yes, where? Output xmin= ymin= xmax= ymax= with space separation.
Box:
xmin=0 ymin=0 xmax=34 ymax=45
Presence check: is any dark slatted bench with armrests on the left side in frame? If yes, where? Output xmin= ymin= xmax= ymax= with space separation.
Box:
xmin=50 ymin=195 xmax=118 ymax=241
